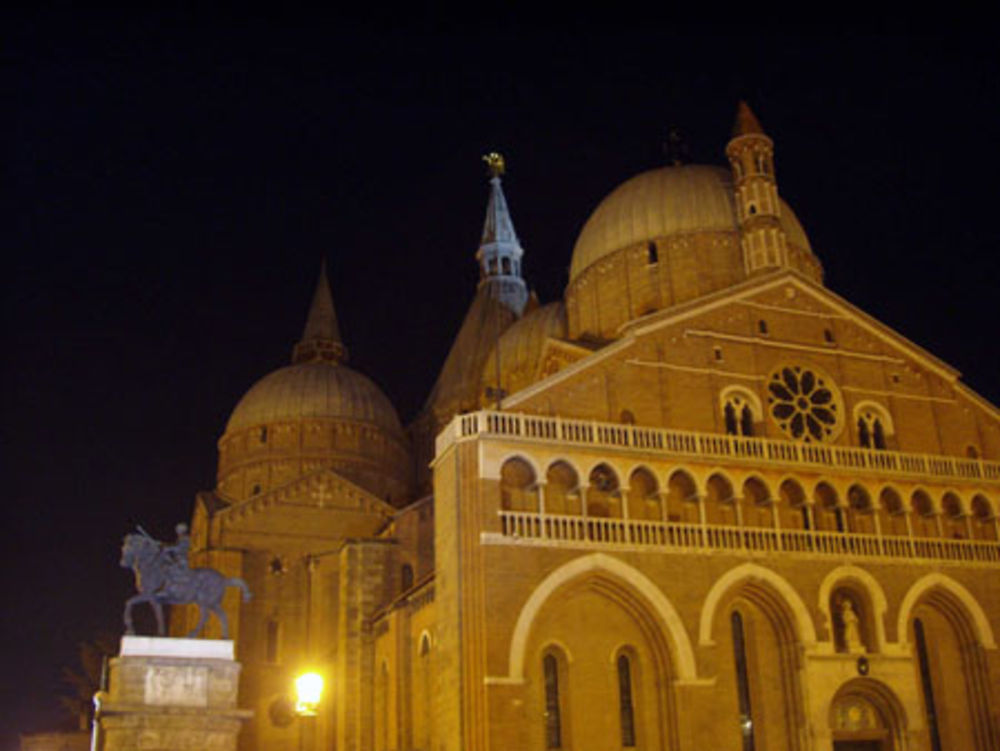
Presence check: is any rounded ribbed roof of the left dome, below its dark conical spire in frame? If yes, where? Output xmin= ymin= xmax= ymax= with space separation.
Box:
xmin=226 ymin=361 xmax=402 ymax=435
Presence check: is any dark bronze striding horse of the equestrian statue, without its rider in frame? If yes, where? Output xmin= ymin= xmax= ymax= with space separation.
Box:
xmin=121 ymin=534 xmax=250 ymax=639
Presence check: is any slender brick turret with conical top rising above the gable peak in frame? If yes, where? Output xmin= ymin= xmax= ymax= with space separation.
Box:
xmin=726 ymin=101 xmax=789 ymax=275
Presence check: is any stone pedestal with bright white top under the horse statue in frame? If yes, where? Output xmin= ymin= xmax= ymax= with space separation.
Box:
xmin=95 ymin=636 xmax=253 ymax=751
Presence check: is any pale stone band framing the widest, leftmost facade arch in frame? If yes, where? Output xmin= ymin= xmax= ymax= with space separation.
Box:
xmin=506 ymin=553 xmax=697 ymax=683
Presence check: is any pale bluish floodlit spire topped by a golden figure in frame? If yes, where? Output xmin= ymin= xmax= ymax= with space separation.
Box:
xmin=476 ymin=152 xmax=528 ymax=316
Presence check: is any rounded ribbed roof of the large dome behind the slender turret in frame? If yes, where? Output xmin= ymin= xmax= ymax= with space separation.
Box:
xmin=569 ymin=165 xmax=812 ymax=282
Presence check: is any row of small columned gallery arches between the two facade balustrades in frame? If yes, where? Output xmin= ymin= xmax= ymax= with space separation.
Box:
xmin=500 ymin=456 xmax=998 ymax=540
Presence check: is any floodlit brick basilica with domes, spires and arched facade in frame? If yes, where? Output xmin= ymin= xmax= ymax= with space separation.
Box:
xmin=171 ymin=104 xmax=1000 ymax=751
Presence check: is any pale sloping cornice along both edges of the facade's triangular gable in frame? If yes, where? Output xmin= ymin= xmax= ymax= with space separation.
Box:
xmin=504 ymin=270 xmax=1000 ymax=419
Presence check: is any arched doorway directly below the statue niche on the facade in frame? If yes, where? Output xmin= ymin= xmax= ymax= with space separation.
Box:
xmin=830 ymin=678 xmax=905 ymax=751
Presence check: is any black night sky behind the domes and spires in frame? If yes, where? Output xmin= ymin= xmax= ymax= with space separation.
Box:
xmin=0 ymin=12 xmax=1000 ymax=749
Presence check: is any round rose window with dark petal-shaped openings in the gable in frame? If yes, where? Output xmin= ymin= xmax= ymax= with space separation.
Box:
xmin=767 ymin=365 xmax=844 ymax=443
